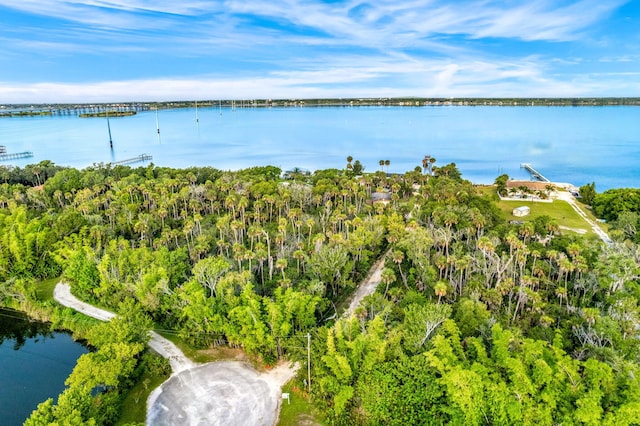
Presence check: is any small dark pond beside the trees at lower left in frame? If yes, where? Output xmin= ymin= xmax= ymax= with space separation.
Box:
xmin=0 ymin=309 xmax=88 ymax=426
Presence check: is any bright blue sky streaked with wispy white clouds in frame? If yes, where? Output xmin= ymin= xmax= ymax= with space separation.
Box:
xmin=0 ymin=0 xmax=640 ymax=104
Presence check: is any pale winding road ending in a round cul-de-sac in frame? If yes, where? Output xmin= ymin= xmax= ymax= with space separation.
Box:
xmin=54 ymin=283 xmax=298 ymax=426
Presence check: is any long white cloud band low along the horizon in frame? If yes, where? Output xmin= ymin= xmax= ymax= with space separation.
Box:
xmin=0 ymin=52 xmax=639 ymax=103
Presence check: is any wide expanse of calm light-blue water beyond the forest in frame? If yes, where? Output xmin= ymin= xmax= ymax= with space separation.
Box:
xmin=0 ymin=107 xmax=640 ymax=191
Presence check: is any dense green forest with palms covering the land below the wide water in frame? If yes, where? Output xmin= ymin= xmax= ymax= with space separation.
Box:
xmin=0 ymin=157 xmax=640 ymax=425
